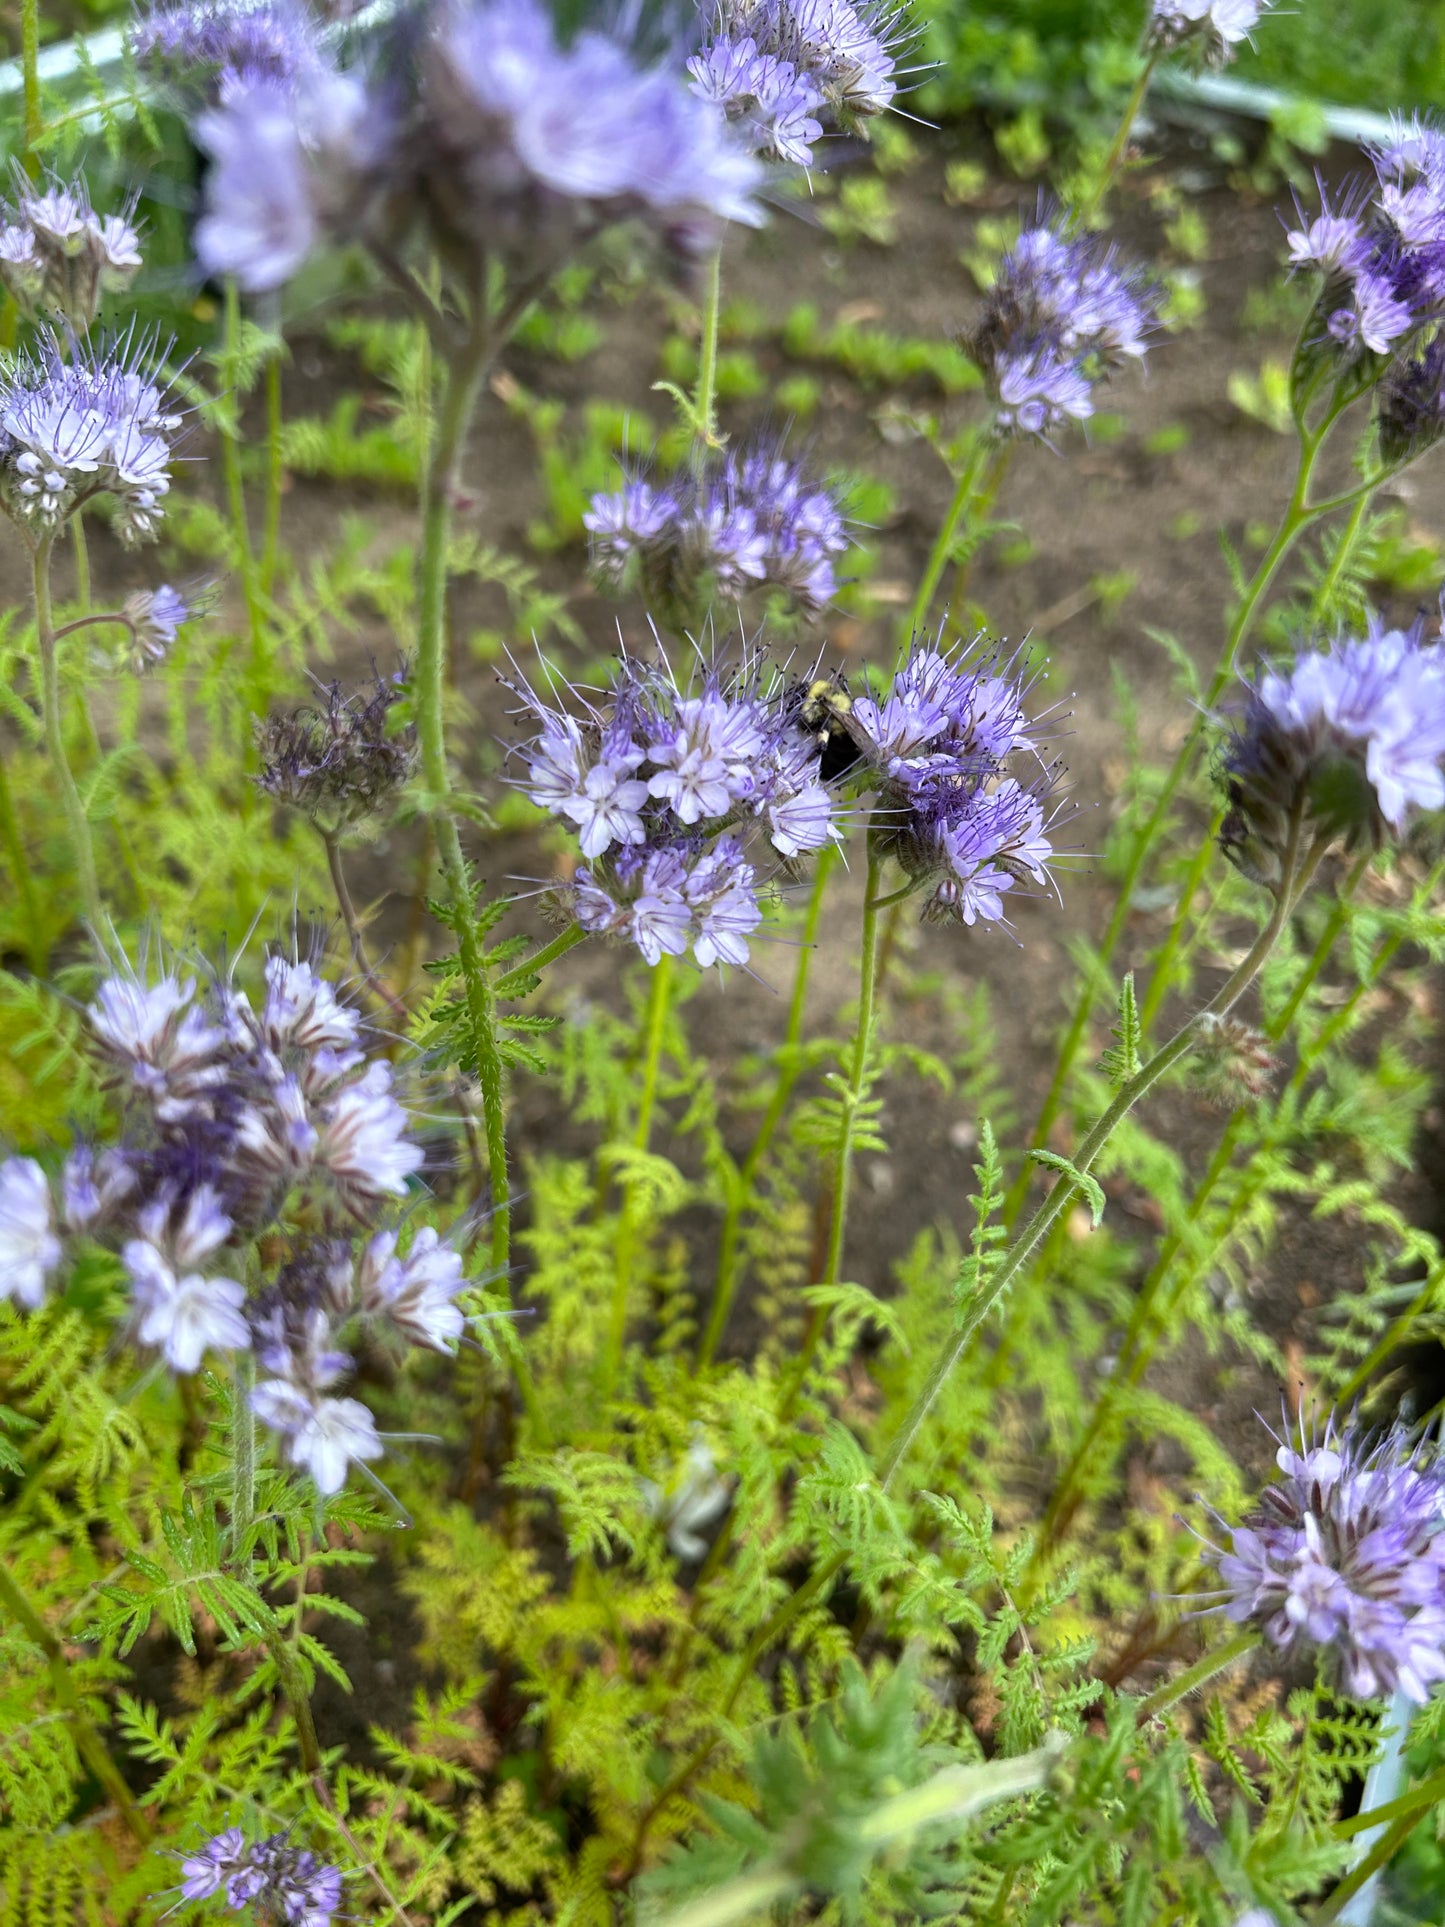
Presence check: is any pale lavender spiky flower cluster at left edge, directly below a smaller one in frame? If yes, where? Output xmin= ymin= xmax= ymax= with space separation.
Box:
xmin=0 ymin=335 xmax=181 ymax=543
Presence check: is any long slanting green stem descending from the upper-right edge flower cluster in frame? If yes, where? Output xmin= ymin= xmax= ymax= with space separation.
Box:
xmin=1004 ymin=409 xmax=1374 ymax=1226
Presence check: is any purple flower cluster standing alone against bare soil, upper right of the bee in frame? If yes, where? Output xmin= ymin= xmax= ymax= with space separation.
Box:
xmin=961 ymin=224 xmax=1156 ymax=437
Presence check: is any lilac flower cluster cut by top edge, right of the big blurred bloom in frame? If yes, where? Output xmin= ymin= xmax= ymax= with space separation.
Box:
xmin=688 ymin=0 xmax=909 ymax=168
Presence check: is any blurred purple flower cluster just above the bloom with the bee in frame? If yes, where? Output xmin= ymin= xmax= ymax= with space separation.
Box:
xmin=582 ymin=443 xmax=848 ymax=628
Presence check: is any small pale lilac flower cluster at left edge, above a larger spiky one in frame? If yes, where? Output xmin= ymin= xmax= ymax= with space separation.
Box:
xmin=0 ymin=172 xmax=141 ymax=333
